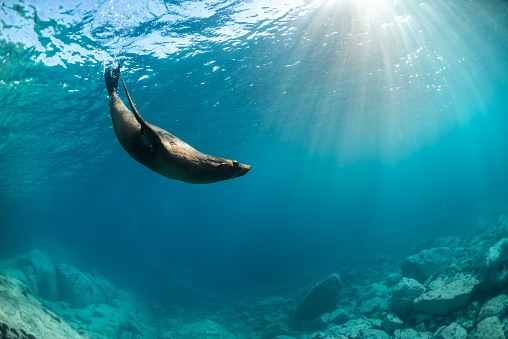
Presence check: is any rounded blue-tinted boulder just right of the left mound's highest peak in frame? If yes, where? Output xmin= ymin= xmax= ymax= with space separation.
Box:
xmin=56 ymin=264 xmax=108 ymax=308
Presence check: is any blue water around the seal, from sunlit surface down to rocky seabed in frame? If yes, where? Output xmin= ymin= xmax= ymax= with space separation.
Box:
xmin=0 ymin=0 xmax=508 ymax=302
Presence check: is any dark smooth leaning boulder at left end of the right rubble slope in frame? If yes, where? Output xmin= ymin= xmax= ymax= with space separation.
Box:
xmin=295 ymin=274 xmax=342 ymax=321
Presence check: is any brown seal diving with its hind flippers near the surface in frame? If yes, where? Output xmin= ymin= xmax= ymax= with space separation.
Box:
xmin=104 ymin=64 xmax=251 ymax=184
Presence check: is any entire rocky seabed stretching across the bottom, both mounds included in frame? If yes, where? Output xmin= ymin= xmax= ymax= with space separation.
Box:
xmin=0 ymin=216 xmax=508 ymax=339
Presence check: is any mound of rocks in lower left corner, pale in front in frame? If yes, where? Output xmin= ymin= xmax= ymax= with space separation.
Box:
xmin=0 ymin=250 xmax=156 ymax=339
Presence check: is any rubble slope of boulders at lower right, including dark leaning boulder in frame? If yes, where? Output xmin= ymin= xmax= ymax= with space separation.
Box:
xmin=284 ymin=216 xmax=508 ymax=339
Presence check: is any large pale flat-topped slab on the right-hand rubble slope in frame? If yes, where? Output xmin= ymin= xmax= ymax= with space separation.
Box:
xmin=413 ymin=276 xmax=478 ymax=315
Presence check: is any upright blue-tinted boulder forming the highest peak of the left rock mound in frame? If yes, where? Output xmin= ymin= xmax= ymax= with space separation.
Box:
xmin=18 ymin=250 xmax=58 ymax=300
